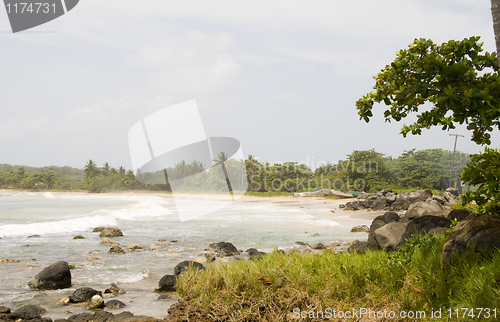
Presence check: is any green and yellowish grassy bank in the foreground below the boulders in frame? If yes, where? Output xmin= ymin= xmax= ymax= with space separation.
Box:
xmin=173 ymin=235 xmax=500 ymax=321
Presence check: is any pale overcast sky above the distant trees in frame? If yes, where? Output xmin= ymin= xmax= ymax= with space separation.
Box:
xmin=0 ymin=0 xmax=500 ymax=169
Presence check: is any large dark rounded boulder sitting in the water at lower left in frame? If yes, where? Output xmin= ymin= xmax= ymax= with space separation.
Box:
xmin=28 ymin=261 xmax=71 ymax=290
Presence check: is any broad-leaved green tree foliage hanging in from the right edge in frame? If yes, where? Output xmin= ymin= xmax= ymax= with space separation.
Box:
xmin=356 ymin=37 xmax=500 ymax=213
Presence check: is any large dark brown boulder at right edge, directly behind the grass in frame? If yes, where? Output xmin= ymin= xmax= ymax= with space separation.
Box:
xmin=441 ymin=215 xmax=500 ymax=269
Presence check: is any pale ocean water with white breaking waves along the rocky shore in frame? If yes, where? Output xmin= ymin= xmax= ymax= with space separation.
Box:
xmin=0 ymin=192 xmax=376 ymax=319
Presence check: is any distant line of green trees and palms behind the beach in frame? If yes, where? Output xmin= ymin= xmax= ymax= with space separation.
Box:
xmin=0 ymin=149 xmax=469 ymax=192
